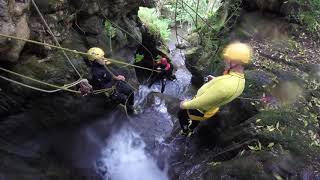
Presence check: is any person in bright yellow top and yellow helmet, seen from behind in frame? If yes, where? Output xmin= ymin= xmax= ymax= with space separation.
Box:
xmin=178 ymin=42 xmax=252 ymax=136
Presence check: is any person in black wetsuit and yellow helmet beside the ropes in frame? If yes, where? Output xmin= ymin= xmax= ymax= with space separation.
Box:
xmin=86 ymin=47 xmax=134 ymax=113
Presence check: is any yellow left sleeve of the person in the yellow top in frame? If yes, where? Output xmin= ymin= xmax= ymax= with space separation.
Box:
xmin=183 ymin=83 xmax=229 ymax=109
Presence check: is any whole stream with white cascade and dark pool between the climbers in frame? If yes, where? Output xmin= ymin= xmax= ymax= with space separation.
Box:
xmin=46 ymin=33 xmax=193 ymax=180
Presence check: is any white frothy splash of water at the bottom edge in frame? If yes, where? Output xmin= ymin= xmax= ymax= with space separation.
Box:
xmin=97 ymin=127 xmax=168 ymax=180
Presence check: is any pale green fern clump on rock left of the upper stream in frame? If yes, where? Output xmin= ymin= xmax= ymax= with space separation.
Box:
xmin=138 ymin=7 xmax=171 ymax=40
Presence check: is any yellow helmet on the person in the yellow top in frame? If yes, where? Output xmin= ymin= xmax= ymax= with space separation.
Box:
xmin=223 ymin=42 xmax=252 ymax=64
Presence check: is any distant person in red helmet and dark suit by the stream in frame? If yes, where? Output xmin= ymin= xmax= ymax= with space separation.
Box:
xmin=148 ymin=57 xmax=174 ymax=93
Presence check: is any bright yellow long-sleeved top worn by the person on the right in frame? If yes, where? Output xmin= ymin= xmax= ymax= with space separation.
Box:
xmin=183 ymin=71 xmax=245 ymax=113
